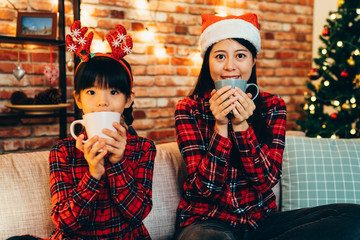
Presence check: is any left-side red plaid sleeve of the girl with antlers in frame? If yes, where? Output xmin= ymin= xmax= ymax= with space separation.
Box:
xmin=49 ymin=144 xmax=105 ymax=232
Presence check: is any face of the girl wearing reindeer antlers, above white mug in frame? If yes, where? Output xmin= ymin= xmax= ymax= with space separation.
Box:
xmin=74 ymin=82 xmax=134 ymax=114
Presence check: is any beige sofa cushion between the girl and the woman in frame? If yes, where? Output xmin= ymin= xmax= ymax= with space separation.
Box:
xmin=144 ymin=142 xmax=187 ymax=239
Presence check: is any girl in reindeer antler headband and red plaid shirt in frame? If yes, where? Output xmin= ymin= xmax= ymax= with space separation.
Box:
xmin=49 ymin=22 xmax=156 ymax=239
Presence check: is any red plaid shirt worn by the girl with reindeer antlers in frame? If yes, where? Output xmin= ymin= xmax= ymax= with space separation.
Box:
xmin=49 ymin=134 xmax=156 ymax=239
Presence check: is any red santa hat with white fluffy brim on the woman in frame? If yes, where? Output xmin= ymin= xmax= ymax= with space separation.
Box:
xmin=200 ymin=13 xmax=261 ymax=57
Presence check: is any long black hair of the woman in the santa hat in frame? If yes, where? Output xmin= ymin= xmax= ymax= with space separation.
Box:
xmin=191 ymin=38 xmax=273 ymax=145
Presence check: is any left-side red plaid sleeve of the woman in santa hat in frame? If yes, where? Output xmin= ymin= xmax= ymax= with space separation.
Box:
xmin=175 ymin=98 xmax=232 ymax=198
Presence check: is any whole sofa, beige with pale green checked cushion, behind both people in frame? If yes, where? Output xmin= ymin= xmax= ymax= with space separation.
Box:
xmin=0 ymin=133 xmax=360 ymax=240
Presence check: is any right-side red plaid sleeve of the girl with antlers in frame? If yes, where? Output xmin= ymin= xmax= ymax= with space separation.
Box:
xmin=106 ymin=135 xmax=156 ymax=222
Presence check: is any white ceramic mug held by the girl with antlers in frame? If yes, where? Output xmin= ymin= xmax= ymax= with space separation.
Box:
xmin=70 ymin=112 xmax=121 ymax=142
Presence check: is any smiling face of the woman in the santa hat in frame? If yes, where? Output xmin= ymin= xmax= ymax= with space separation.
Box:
xmin=209 ymin=39 xmax=256 ymax=82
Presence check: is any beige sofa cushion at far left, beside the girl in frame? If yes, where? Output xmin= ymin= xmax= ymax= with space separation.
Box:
xmin=0 ymin=151 xmax=54 ymax=239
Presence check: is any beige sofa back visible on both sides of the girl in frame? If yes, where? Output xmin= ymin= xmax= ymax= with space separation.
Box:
xmin=0 ymin=142 xmax=186 ymax=240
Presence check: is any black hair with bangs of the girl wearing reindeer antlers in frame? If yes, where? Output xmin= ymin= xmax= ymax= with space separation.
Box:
xmin=74 ymin=56 xmax=134 ymax=134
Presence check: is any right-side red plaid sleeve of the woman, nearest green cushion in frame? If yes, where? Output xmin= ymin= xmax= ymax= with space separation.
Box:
xmin=232 ymin=94 xmax=286 ymax=192
